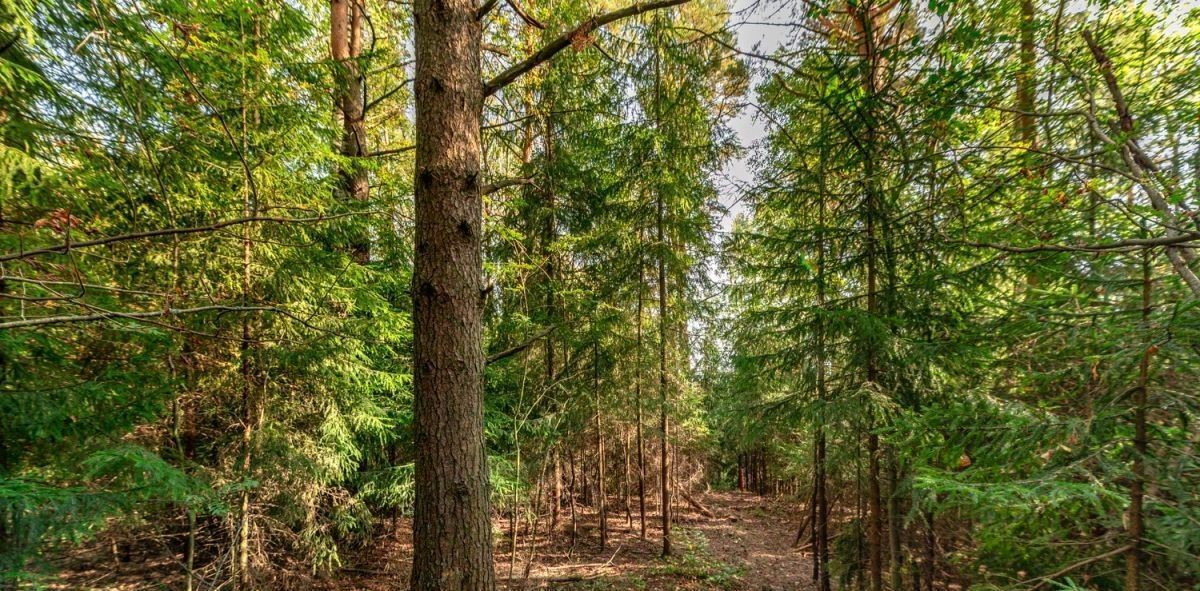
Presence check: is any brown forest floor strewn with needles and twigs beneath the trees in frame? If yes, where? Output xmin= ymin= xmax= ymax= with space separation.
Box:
xmin=50 ymin=491 xmax=812 ymax=591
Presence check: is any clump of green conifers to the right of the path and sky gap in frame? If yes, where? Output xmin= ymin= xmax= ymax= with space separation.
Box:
xmin=720 ymin=1 xmax=1198 ymax=590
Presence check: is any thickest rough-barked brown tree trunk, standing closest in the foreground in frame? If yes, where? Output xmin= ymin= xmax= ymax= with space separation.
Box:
xmin=412 ymin=0 xmax=496 ymax=591
